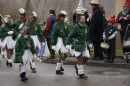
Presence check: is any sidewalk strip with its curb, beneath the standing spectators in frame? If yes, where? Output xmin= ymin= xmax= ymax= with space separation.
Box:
xmin=43 ymin=57 xmax=130 ymax=69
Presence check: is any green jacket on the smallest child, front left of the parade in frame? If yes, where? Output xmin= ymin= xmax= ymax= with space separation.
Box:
xmin=15 ymin=36 xmax=36 ymax=63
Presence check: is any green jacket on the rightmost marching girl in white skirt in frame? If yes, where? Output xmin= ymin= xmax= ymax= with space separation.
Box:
xmin=66 ymin=24 xmax=89 ymax=52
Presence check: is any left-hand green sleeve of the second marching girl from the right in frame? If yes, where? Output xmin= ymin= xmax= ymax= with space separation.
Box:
xmin=51 ymin=24 xmax=58 ymax=45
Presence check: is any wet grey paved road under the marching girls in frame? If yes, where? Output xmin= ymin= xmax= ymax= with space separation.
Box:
xmin=0 ymin=58 xmax=130 ymax=86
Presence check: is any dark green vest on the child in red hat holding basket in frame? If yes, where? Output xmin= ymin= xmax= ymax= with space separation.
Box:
xmin=105 ymin=26 xmax=118 ymax=45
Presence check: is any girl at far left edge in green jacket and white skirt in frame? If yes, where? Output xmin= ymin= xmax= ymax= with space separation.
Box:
xmin=0 ymin=16 xmax=14 ymax=67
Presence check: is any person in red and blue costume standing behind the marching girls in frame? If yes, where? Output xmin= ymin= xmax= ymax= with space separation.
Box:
xmin=43 ymin=8 xmax=56 ymax=59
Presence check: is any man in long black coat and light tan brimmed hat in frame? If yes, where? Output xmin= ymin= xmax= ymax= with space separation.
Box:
xmin=89 ymin=0 xmax=104 ymax=60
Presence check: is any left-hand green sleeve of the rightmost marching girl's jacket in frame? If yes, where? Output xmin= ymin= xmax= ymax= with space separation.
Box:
xmin=66 ymin=27 xmax=77 ymax=45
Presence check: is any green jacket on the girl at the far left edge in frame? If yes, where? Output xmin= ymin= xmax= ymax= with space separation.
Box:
xmin=0 ymin=26 xmax=11 ymax=42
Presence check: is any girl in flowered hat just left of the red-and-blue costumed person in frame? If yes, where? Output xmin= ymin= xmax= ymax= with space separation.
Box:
xmin=27 ymin=11 xmax=45 ymax=73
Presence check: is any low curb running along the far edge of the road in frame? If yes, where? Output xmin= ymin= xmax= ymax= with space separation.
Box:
xmin=42 ymin=58 xmax=130 ymax=69
